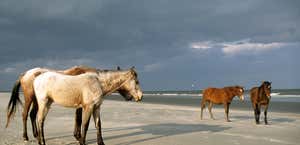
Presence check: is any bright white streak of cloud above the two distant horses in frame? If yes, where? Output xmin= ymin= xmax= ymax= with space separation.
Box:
xmin=189 ymin=39 xmax=292 ymax=55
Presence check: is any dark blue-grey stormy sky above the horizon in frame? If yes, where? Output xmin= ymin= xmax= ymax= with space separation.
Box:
xmin=0 ymin=0 xmax=300 ymax=90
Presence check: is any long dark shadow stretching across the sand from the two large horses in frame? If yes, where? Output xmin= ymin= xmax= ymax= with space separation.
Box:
xmin=87 ymin=123 xmax=231 ymax=145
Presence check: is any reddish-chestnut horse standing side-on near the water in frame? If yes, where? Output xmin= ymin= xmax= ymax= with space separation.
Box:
xmin=201 ymin=86 xmax=244 ymax=122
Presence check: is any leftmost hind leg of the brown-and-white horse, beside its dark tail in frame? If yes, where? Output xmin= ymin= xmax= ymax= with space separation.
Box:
xmin=22 ymin=93 xmax=33 ymax=141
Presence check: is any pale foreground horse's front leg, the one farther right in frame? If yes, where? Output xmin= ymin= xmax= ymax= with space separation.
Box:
xmin=93 ymin=106 xmax=104 ymax=145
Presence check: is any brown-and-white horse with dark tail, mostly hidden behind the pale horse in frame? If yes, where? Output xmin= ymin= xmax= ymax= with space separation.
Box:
xmin=6 ymin=66 xmax=136 ymax=141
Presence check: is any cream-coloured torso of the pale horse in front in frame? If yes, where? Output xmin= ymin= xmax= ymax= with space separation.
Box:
xmin=34 ymin=72 xmax=101 ymax=107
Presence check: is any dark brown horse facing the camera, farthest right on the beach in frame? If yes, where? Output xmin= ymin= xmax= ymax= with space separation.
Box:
xmin=250 ymin=81 xmax=272 ymax=124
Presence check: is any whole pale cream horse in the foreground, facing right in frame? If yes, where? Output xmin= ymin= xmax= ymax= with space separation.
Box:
xmin=33 ymin=68 xmax=142 ymax=144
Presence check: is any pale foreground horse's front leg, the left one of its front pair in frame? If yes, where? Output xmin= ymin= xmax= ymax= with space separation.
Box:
xmin=79 ymin=106 xmax=92 ymax=145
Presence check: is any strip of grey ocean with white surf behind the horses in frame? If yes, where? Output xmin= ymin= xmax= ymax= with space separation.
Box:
xmin=106 ymin=89 xmax=300 ymax=113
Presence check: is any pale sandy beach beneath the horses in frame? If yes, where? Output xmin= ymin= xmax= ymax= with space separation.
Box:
xmin=0 ymin=93 xmax=300 ymax=145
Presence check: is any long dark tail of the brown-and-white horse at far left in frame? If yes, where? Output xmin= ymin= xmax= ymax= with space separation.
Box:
xmin=5 ymin=74 xmax=23 ymax=128
